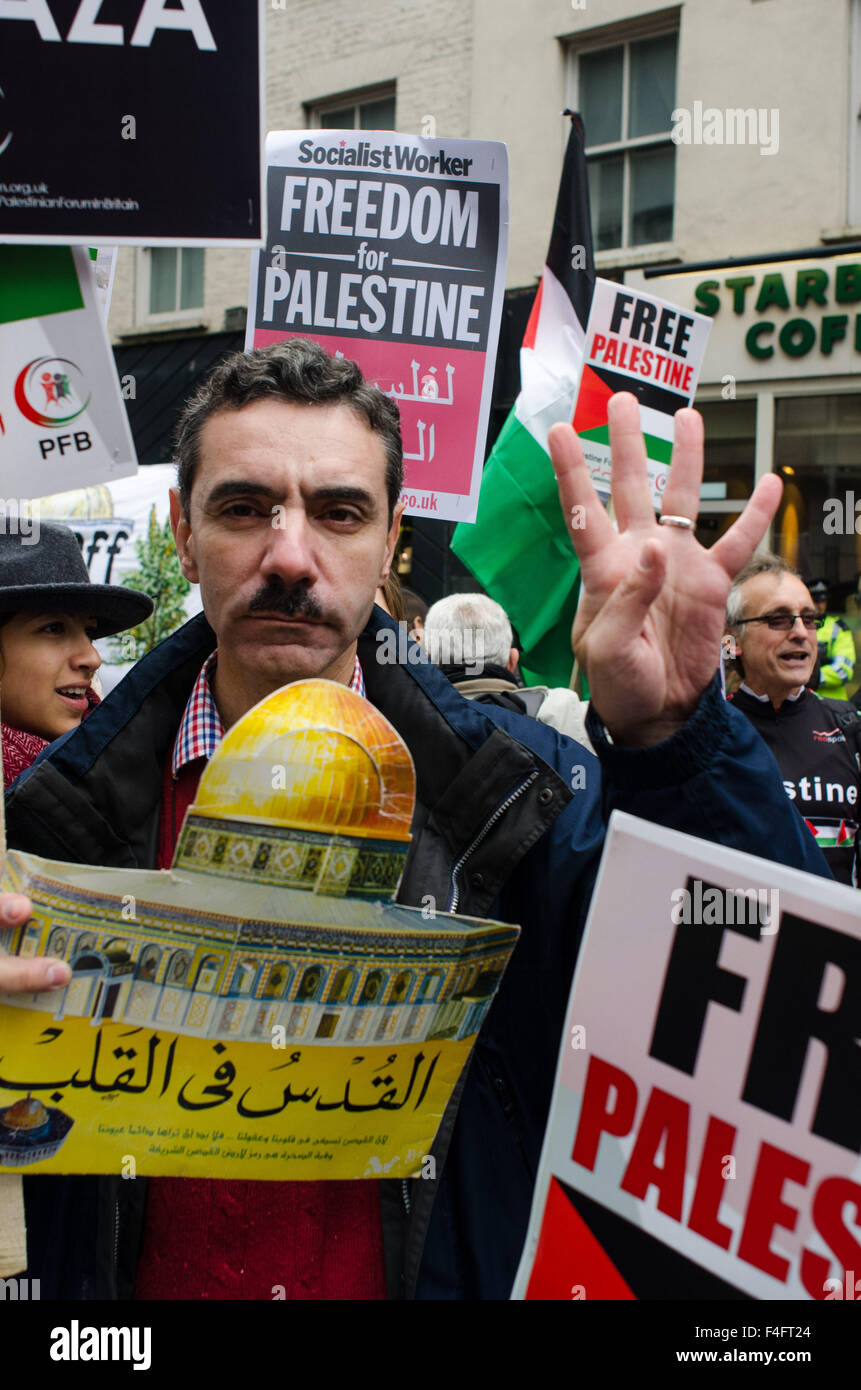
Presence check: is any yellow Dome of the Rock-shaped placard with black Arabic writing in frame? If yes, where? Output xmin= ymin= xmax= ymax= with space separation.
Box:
xmin=0 ymin=680 xmax=519 ymax=1179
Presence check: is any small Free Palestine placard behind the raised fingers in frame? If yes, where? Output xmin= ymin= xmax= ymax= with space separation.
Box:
xmin=573 ymin=279 xmax=712 ymax=510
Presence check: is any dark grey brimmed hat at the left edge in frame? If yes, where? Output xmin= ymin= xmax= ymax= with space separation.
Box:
xmin=0 ymin=521 xmax=153 ymax=637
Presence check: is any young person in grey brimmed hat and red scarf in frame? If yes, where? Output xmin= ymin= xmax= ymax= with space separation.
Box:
xmin=0 ymin=521 xmax=153 ymax=788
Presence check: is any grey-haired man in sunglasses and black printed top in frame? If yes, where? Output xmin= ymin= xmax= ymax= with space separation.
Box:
xmin=725 ymin=555 xmax=861 ymax=885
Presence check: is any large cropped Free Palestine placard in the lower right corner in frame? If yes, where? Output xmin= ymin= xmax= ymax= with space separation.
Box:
xmin=515 ymin=812 xmax=861 ymax=1300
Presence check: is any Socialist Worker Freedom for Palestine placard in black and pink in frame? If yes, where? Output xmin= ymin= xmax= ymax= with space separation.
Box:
xmin=246 ymin=131 xmax=508 ymax=521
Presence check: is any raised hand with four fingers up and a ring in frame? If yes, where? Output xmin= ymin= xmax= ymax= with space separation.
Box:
xmin=548 ymin=392 xmax=783 ymax=746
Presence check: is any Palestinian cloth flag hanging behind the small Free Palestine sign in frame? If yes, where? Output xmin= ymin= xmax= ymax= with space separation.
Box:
xmin=452 ymin=115 xmax=595 ymax=685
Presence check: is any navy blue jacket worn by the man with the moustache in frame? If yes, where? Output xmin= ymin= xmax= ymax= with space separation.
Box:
xmin=7 ymin=609 xmax=829 ymax=1298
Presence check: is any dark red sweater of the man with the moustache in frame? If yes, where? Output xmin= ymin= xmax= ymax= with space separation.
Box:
xmin=135 ymin=758 xmax=385 ymax=1300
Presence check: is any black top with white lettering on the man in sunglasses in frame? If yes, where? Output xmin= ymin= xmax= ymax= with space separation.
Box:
xmin=730 ymin=685 xmax=861 ymax=884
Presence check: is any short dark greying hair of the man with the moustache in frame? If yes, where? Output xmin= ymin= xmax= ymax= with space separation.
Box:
xmin=174 ymin=338 xmax=403 ymax=524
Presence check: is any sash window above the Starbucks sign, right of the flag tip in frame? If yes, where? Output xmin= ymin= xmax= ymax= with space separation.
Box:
xmin=573 ymin=33 xmax=679 ymax=252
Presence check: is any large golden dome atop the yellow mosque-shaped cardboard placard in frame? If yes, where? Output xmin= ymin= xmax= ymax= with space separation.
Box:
xmin=189 ymin=680 xmax=416 ymax=840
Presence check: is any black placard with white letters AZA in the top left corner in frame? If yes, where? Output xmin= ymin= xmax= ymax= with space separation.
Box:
xmin=0 ymin=0 xmax=264 ymax=246
